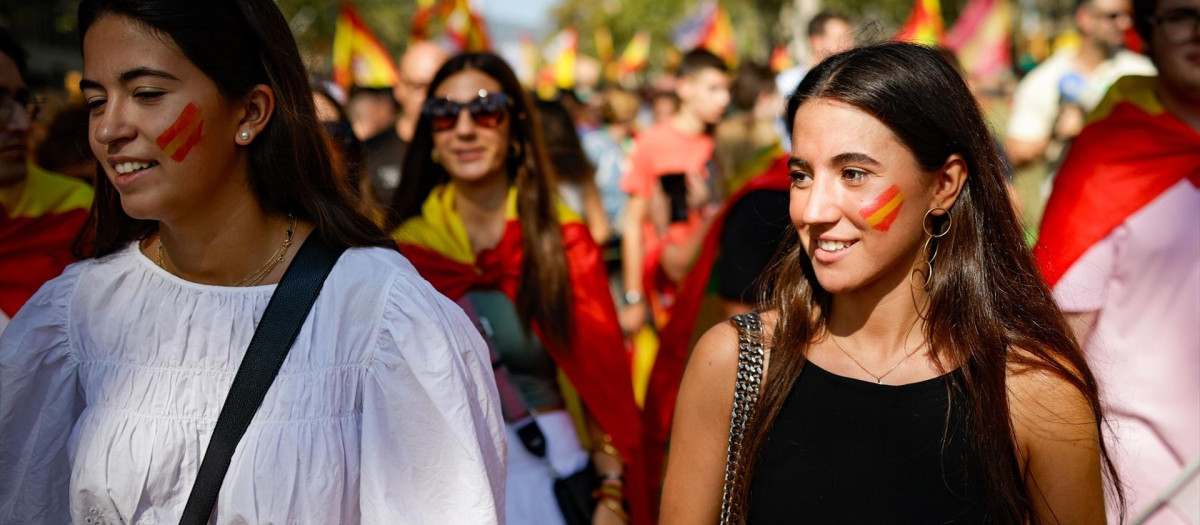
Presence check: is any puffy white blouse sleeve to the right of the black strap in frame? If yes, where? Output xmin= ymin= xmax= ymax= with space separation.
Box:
xmin=361 ymin=263 xmax=505 ymax=525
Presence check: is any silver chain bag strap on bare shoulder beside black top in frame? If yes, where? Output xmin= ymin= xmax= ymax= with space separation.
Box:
xmin=721 ymin=312 xmax=763 ymax=525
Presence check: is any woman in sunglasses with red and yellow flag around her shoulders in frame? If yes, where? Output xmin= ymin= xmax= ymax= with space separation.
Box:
xmin=389 ymin=53 xmax=649 ymax=524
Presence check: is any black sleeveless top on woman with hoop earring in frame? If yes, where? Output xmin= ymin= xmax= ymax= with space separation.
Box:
xmin=746 ymin=362 xmax=984 ymax=524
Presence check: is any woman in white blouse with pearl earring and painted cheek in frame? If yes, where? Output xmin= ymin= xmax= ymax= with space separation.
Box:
xmin=0 ymin=0 xmax=505 ymax=524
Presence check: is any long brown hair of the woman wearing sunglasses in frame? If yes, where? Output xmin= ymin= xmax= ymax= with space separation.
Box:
xmin=388 ymin=53 xmax=571 ymax=344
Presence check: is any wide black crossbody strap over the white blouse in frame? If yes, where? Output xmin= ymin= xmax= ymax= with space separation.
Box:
xmin=179 ymin=234 xmax=343 ymax=525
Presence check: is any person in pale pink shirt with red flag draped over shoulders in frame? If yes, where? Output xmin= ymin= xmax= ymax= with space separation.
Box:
xmin=1034 ymin=0 xmax=1200 ymax=517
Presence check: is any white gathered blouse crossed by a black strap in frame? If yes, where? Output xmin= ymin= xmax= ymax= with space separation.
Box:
xmin=0 ymin=245 xmax=505 ymax=525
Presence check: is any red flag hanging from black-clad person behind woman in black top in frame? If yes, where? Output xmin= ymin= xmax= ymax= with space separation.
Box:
xmin=642 ymin=153 xmax=791 ymax=496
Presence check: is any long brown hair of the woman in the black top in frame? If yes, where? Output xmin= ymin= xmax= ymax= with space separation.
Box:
xmin=734 ymin=43 xmax=1123 ymax=523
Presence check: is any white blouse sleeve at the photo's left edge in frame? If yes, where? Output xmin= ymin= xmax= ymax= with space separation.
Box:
xmin=0 ymin=263 xmax=86 ymax=523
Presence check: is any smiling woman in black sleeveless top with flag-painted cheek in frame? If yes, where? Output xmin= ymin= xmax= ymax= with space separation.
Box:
xmin=662 ymin=43 xmax=1120 ymax=524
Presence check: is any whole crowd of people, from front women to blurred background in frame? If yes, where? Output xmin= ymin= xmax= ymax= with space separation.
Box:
xmin=0 ymin=0 xmax=1200 ymax=525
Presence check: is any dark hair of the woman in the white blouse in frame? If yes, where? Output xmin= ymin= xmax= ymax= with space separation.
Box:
xmin=74 ymin=0 xmax=395 ymax=258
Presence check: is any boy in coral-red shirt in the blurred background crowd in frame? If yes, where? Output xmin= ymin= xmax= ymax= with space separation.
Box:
xmin=620 ymin=49 xmax=730 ymax=333
